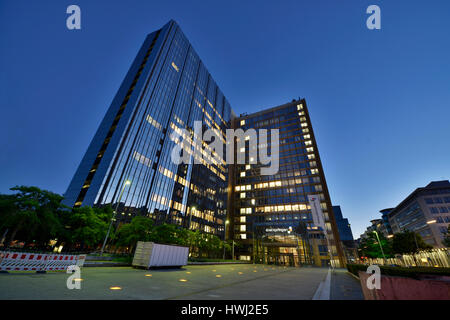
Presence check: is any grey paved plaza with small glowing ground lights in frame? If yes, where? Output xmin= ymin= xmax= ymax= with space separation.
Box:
xmin=0 ymin=264 xmax=363 ymax=300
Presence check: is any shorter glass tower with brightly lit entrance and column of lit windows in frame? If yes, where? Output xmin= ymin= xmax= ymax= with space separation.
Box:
xmin=230 ymin=99 xmax=344 ymax=266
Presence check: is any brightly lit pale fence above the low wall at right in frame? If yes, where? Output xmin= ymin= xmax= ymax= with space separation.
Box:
xmin=362 ymin=248 xmax=450 ymax=268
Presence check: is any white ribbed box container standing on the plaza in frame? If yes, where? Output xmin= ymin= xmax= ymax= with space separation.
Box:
xmin=132 ymin=241 xmax=189 ymax=268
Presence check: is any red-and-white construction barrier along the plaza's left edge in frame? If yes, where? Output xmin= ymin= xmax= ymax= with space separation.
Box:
xmin=0 ymin=252 xmax=86 ymax=271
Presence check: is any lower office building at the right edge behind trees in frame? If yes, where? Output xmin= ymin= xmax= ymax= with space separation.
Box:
xmin=387 ymin=180 xmax=450 ymax=248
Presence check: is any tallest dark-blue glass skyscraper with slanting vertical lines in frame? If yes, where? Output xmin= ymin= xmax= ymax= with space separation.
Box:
xmin=64 ymin=21 xmax=232 ymax=236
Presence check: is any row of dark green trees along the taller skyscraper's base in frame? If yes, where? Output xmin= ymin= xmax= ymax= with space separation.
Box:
xmin=0 ymin=186 xmax=239 ymax=258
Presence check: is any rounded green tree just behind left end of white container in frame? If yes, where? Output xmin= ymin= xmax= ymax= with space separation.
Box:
xmin=115 ymin=216 xmax=154 ymax=252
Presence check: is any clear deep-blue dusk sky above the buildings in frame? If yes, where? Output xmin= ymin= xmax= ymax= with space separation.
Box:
xmin=0 ymin=0 xmax=450 ymax=238
